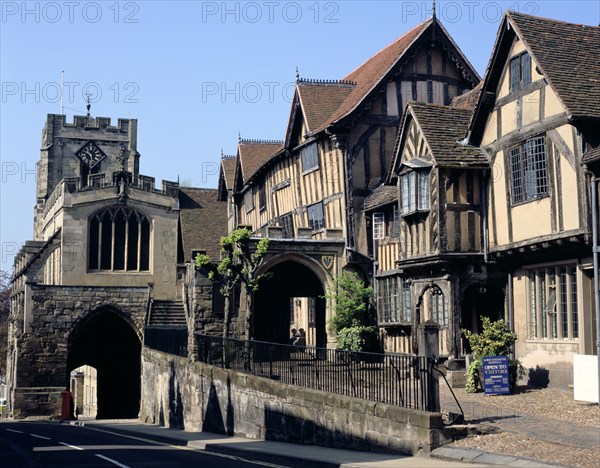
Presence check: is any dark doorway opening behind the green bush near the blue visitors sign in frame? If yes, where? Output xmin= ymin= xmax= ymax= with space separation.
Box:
xmin=461 ymin=283 xmax=504 ymax=354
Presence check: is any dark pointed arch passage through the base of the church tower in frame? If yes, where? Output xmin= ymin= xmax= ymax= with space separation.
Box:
xmin=67 ymin=308 xmax=142 ymax=419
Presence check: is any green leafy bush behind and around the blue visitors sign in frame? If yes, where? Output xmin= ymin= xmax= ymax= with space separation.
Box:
xmin=463 ymin=316 xmax=524 ymax=393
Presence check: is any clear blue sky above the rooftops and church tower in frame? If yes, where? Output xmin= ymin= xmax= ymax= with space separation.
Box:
xmin=0 ymin=0 xmax=600 ymax=269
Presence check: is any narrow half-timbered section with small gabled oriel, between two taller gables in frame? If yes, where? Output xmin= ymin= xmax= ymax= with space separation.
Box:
xmin=365 ymin=94 xmax=503 ymax=357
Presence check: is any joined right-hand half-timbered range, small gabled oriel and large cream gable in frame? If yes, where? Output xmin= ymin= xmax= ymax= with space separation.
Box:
xmin=364 ymin=12 xmax=600 ymax=392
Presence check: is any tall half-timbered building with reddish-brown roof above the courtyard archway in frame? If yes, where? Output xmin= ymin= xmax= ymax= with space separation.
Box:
xmin=220 ymin=13 xmax=479 ymax=345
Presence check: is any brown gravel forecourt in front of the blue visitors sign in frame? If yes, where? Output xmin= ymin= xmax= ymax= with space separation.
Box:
xmin=440 ymin=386 xmax=600 ymax=468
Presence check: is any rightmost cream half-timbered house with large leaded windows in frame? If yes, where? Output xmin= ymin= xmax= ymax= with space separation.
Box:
xmin=469 ymin=12 xmax=600 ymax=386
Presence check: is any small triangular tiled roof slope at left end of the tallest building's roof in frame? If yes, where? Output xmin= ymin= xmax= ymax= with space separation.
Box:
xmin=298 ymin=80 xmax=354 ymax=132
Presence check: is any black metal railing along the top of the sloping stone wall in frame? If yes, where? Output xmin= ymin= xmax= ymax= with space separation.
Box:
xmin=196 ymin=335 xmax=439 ymax=412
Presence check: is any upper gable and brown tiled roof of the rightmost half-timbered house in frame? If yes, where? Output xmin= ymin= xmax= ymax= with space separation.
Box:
xmin=469 ymin=11 xmax=600 ymax=145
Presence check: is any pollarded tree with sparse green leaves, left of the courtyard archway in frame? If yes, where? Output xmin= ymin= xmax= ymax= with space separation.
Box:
xmin=195 ymin=228 xmax=269 ymax=340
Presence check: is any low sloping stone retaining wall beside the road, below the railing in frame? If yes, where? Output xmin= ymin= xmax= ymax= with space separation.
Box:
xmin=140 ymin=348 xmax=448 ymax=454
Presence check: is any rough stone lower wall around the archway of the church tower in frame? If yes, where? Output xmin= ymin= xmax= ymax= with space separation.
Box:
xmin=8 ymin=284 xmax=148 ymax=418
